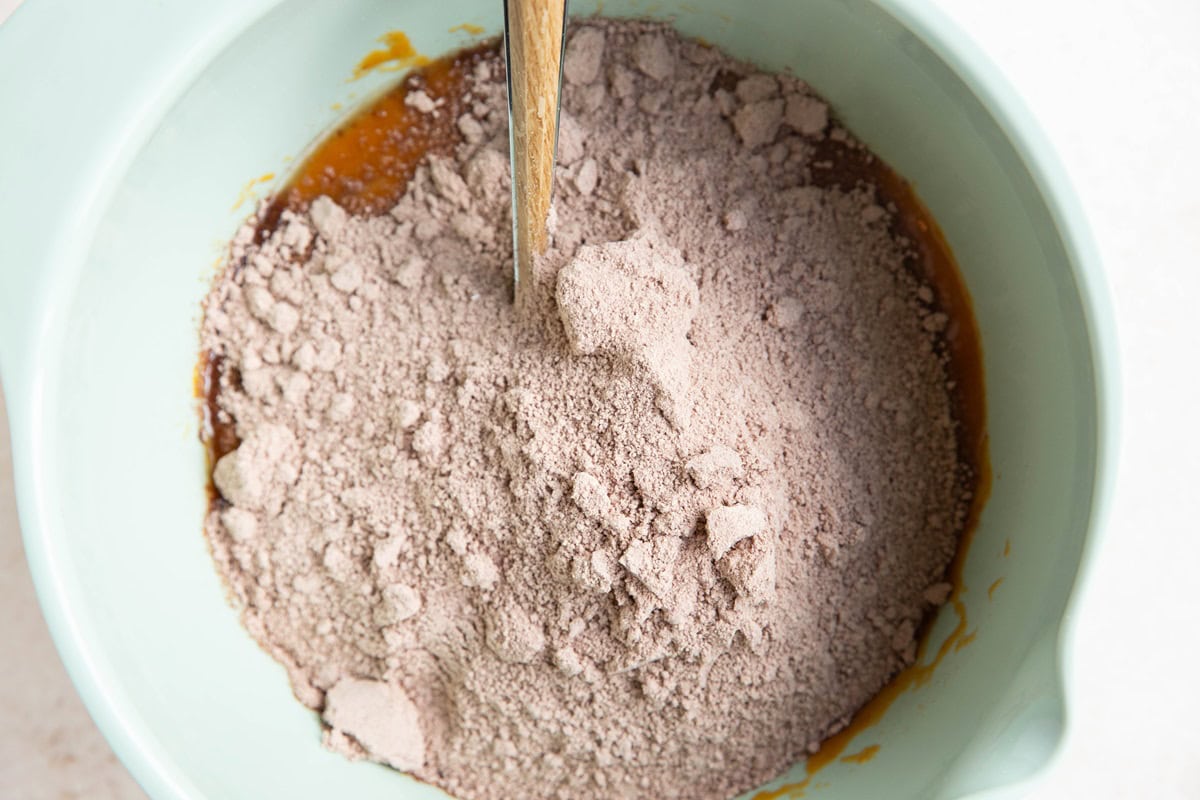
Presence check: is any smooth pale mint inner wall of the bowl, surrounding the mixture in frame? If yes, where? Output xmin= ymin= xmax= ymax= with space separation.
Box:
xmin=31 ymin=0 xmax=1097 ymax=800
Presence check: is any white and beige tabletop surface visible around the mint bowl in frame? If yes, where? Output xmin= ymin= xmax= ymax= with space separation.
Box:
xmin=0 ymin=0 xmax=1200 ymax=800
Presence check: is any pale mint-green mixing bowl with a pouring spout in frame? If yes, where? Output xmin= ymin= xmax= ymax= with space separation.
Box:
xmin=0 ymin=0 xmax=1116 ymax=800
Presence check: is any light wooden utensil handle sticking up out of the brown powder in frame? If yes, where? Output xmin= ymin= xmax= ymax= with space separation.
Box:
xmin=504 ymin=0 xmax=566 ymax=307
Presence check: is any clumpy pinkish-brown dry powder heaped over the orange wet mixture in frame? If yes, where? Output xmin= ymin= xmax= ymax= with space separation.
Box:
xmin=203 ymin=22 xmax=970 ymax=799
